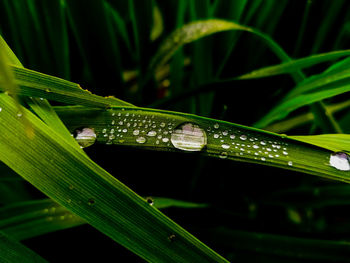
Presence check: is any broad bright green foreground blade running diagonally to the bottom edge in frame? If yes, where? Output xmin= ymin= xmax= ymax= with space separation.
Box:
xmin=0 ymin=94 xmax=227 ymax=262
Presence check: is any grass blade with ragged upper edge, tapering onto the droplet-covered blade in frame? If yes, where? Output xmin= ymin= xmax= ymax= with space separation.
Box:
xmin=5 ymin=66 xmax=131 ymax=107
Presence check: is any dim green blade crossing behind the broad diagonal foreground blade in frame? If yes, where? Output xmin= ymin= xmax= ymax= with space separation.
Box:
xmin=0 ymin=197 xmax=208 ymax=240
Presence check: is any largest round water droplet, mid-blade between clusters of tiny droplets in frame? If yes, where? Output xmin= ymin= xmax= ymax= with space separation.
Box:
xmin=170 ymin=122 xmax=207 ymax=151
